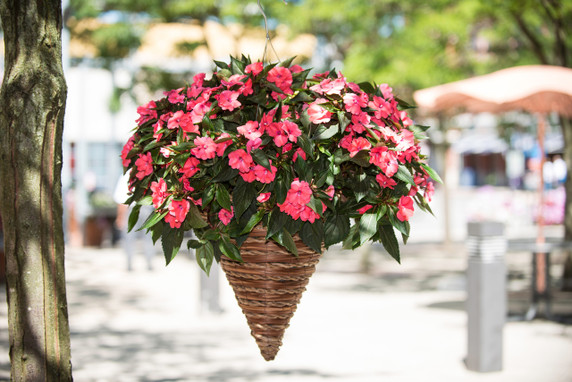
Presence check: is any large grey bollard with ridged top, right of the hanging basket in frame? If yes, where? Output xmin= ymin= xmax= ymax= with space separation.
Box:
xmin=465 ymin=221 xmax=507 ymax=372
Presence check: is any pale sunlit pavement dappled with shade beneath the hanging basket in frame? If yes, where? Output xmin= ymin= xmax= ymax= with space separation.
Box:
xmin=0 ymin=243 xmax=572 ymax=382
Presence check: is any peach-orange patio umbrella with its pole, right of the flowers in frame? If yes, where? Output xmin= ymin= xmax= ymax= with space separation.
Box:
xmin=413 ymin=65 xmax=572 ymax=291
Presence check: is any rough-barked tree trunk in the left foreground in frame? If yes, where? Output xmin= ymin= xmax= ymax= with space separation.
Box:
xmin=0 ymin=0 xmax=72 ymax=382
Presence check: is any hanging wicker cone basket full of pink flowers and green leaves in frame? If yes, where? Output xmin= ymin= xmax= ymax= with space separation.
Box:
xmin=121 ymin=56 xmax=439 ymax=360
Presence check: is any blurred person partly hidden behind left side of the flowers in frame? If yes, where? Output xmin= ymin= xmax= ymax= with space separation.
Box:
xmin=113 ymin=173 xmax=155 ymax=271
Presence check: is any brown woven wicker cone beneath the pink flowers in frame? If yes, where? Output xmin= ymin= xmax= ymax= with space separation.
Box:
xmin=221 ymin=225 xmax=320 ymax=361
